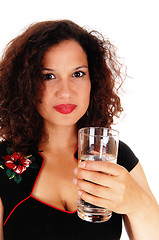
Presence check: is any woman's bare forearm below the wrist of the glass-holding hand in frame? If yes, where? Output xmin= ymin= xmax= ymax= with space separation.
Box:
xmin=124 ymin=193 xmax=159 ymax=240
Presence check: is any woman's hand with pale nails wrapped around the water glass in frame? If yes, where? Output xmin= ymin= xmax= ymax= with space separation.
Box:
xmin=74 ymin=161 xmax=144 ymax=215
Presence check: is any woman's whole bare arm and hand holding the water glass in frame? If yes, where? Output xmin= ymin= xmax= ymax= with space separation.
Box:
xmin=73 ymin=154 xmax=159 ymax=240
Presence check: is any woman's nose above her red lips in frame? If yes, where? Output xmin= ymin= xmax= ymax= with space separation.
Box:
xmin=56 ymin=79 xmax=72 ymax=100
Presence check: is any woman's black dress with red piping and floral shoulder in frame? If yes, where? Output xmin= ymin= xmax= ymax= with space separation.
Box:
xmin=0 ymin=141 xmax=138 ymax=240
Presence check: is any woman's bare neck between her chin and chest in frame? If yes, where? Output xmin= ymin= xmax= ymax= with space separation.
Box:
xmin=39 ymin=125 xmax=77 ymax=152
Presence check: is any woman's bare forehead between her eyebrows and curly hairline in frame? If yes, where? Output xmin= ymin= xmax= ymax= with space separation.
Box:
xmin=43 ymin=40 xmax=87 ymax=65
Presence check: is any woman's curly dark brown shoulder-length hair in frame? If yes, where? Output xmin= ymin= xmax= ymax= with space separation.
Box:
xmin=0 ymin=20 xmax=122 ymax=154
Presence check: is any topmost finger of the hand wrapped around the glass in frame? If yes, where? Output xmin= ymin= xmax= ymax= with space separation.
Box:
xmin=78 ymin=160 xmax=124 ymax=176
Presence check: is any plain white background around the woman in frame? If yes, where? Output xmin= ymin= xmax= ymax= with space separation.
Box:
xmin=0 ymin=0 xmax=159 ymax=240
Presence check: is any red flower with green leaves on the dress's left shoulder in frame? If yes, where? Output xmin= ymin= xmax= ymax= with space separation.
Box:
xmin=0 ymin=149 xmax=37 ymax=183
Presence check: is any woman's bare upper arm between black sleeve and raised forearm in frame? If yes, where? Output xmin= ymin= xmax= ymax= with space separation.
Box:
xmin=130 ymin=162 xmax=157 ymax=203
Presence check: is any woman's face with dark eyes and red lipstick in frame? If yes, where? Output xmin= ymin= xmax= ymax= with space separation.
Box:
xmin=37 ymin=40 xmax=91 ymax=127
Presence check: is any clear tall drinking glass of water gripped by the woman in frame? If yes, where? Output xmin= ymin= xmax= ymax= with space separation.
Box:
xmin=77 ymin=127 xmax=119 ymax=222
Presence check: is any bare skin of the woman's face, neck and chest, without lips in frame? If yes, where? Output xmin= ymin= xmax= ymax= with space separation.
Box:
xmin=28 ymin=40 xmax=91 ymax=211
